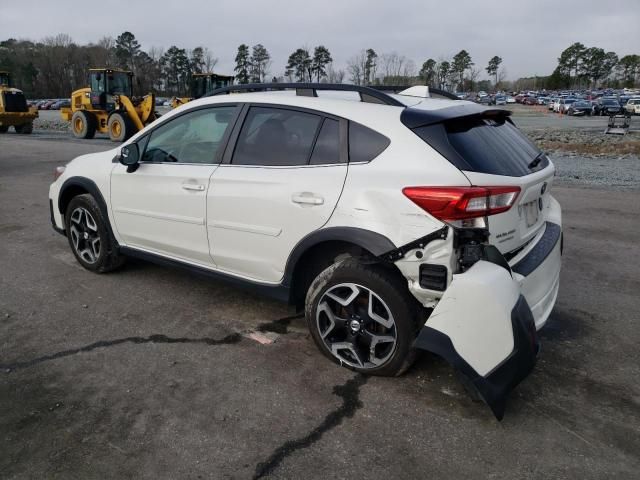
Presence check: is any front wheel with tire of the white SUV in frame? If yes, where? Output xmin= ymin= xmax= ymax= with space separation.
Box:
xmin=65 ymin=193 xmax=125 ymax=273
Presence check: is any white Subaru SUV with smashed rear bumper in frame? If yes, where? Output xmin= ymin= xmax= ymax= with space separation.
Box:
xmin=49 ymin=84 xmax=562 ymax=418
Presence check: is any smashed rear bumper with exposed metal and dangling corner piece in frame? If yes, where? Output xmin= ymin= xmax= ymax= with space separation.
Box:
xmin=381 ymin=218 xmax=562 ymax=420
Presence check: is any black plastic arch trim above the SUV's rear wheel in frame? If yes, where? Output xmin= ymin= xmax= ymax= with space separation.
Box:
xmin=282 ymin=227 xmax=396 ymax=286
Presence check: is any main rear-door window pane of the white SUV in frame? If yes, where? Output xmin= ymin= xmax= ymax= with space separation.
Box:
xmin=231 ymin=107 xmax=322 ymax=166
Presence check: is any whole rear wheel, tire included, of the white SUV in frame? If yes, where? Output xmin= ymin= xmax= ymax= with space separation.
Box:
xmin=305 ymin=257 xmax=422 ymax=376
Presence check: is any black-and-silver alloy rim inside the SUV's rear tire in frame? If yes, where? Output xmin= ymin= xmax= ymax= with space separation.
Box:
xmin=316 ymin=283 xmax=397 ymax=370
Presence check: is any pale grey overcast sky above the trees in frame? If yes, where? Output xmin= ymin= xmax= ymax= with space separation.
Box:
xmin=0 ymin=0 xmax=640 ymax=79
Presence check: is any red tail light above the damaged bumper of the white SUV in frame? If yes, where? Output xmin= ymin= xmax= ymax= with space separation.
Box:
xmin=402 ymin=187 xmax=520 ymax=221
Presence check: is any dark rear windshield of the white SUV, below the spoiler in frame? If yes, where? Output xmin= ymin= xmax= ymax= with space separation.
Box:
xmin=414 ymin=116 xmax=549 ymax=177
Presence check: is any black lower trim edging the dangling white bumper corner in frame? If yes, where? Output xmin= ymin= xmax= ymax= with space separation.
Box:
xmin=414 ymin=295 xmax=539 ymax=420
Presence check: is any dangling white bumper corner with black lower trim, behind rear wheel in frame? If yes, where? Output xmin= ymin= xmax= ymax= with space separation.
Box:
xmin=415 ymin=260 xmax=538 ymax=420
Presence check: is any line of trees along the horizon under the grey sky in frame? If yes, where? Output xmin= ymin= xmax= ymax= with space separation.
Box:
xmin=0 ymin=32 xmax=640 ymax=98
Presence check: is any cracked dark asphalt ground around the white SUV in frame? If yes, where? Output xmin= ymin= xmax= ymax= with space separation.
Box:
xmin=0 ymin=129 xmax=640 ymax=479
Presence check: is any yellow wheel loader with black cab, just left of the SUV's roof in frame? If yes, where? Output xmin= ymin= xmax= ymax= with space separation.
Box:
xmin=60 ymin=68 xmax=157 ymax=142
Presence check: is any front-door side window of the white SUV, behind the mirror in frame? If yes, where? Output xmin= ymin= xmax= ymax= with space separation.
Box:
xmin=141 ymin=106 xmax=236 ymax=164
